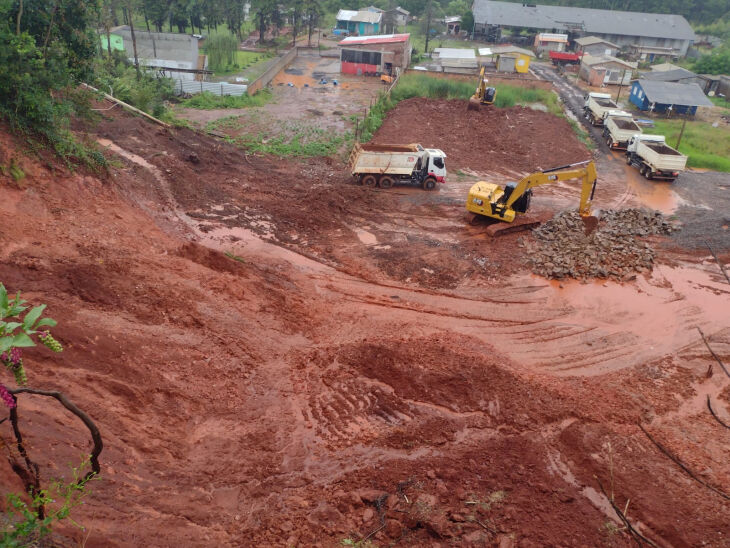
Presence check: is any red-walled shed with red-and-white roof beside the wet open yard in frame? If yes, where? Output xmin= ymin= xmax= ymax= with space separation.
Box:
xmin=339 ymin=34 xmax=411 ymax=75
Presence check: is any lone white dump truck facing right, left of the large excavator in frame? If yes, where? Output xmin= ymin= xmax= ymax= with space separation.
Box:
xmin=348 ymin=143 xmax=446 ymax=190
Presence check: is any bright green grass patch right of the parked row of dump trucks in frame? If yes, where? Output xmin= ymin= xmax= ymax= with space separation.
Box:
xmin=644 ymin=120 xmax=730 ymax=173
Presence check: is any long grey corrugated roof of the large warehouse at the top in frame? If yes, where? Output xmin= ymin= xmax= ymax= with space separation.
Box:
xmin=472 ymin=0 xmax=695 ymax=40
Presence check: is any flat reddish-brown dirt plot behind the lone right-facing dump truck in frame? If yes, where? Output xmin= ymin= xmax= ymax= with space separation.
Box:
xmin=373 ymin=98 xmax=590 ymax=173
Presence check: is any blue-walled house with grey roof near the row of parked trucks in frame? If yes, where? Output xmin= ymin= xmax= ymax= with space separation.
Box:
xmin=629 ymin=79 xmax=712 ymax=115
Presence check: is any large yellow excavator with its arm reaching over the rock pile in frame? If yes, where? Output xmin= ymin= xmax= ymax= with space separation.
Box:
xmin=466 ymin=160 xmax=598 ymax=236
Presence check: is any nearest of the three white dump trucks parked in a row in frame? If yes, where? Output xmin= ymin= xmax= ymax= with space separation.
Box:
xmin=626 ymin=134 xmax=687 ymax=182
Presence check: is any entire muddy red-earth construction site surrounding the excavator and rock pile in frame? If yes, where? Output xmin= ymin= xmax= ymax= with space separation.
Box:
xmin=0 ymin=59 xmax=730 ymax=548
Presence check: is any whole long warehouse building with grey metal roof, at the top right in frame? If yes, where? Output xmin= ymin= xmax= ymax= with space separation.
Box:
xmin=472 ymin=0 xmax=695 ymax=57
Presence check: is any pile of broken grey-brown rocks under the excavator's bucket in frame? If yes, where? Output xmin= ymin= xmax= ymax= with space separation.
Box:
xmin=528 ymin=209 xmax=673 ymax=280
